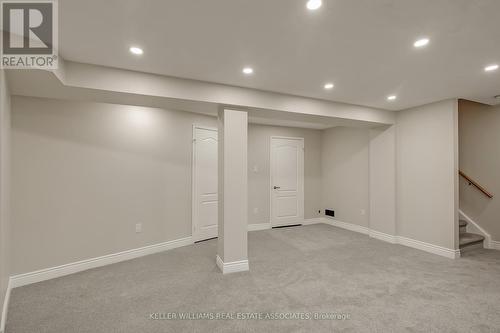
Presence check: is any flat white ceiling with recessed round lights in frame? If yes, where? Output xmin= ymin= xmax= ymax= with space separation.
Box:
xmin=59 ymin=0 xmax=500 ymax=110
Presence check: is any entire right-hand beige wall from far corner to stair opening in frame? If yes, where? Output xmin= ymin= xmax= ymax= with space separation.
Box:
xmin=322 ymin=100 xmax=458 ymax=249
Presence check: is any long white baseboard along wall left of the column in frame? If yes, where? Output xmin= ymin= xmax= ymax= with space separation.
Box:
xmin=10 ymin=237 xmax=193 ymax=288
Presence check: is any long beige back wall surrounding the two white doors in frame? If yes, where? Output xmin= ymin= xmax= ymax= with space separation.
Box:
xmin=12 ymin=96 xmax=321 ymax=275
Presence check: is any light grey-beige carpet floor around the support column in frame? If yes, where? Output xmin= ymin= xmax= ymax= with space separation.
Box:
xmin=7 ymin=225 xmax=500 ymax=333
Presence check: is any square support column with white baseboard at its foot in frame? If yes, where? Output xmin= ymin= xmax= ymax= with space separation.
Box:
xmin=217 ymin=109 xmax=249 ymax=274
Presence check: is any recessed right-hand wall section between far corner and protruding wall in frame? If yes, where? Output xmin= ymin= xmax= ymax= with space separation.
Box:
xmin=321 ymin=126 xmax=396 ymax=235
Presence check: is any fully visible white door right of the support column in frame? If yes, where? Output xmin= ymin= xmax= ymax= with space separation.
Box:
xmin=271 ymin=137 xmax=304 ymax=226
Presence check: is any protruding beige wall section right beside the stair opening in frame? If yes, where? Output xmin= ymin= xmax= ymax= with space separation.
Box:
xmin=396 ymin=100 xmax=458 ymax=249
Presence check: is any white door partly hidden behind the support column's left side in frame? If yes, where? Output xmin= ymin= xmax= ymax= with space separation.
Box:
xmin=193 ymin=126 xmax=218 ymax=242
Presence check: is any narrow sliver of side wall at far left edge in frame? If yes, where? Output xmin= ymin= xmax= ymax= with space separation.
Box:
xmin=0 ymin=70 xmax=10 ymax=322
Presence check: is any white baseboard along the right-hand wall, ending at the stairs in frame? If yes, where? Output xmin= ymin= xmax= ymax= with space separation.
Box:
xmin=324 ymin=217 xmax=460 ymax=259
